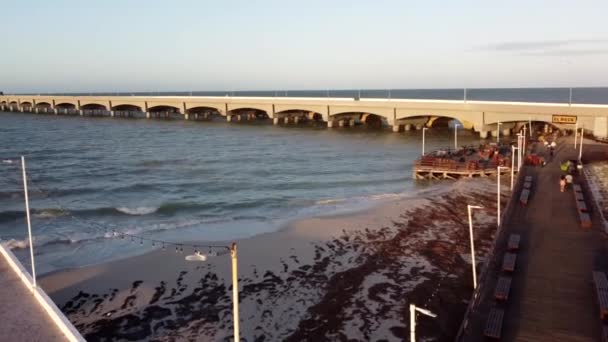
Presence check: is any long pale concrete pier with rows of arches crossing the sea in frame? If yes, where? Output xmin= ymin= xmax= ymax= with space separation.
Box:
xmin=0 ymin=95 xmax=608 ymax=138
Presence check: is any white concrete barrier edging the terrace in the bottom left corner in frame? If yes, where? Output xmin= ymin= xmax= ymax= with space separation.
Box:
xmin=0 ymin=243 xmax=86 ymax=342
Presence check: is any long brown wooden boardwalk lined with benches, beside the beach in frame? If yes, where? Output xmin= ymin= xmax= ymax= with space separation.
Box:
xmin=463 ymin=139 xmax=608 ymax=341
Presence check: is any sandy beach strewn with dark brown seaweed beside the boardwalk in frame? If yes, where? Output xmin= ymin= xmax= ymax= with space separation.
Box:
xmin=41 ymin=179 xmax=509 ymax=341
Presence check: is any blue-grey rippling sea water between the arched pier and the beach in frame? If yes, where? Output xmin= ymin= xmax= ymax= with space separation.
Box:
xmin=0 ymin=113 xmax=478 ymax=274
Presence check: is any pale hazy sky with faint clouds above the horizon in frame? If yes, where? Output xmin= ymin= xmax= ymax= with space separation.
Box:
xmin=0 ymin=0 xmax=608 ymax=92
